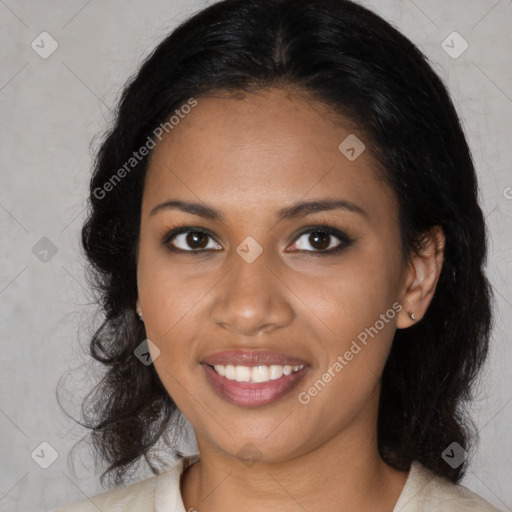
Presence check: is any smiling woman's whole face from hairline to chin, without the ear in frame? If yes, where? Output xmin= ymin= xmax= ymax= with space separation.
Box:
xmin=137 ymin=90 xmax=416 ymax=462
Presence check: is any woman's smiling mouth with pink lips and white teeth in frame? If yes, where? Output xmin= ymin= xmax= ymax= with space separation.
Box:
xmin=201 ymin=351 xmax=309 ymax=407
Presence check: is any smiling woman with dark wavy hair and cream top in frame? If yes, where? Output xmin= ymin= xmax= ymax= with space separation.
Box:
xmin=54 ymin=0 xmax=497 ymax=512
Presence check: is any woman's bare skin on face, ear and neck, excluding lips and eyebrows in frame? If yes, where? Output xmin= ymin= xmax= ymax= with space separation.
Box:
xmin=137 ymin=89 xmax=444 ymax=512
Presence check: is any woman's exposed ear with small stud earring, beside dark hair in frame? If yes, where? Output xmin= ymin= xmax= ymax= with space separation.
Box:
xmin=397 ymin=226 xmax=446 ymax=329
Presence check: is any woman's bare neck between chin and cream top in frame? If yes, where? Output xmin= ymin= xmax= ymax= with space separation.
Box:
xmin=182 ymin=402 xmax=408 ymax=512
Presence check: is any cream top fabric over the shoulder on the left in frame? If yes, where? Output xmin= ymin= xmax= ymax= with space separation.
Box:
xmin=54 ymin=456 xmax=197 ymax=512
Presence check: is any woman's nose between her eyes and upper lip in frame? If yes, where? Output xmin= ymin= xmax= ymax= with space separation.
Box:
xmin=211 ymin=246 xmax=294 ymax=337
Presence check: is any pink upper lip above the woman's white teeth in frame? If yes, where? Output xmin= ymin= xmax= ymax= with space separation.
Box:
xmin=201 ymin=350 xmax=307 ymax=366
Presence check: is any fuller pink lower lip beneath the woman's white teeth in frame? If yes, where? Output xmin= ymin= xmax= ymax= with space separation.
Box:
xmin=202 ymin=364 xmax=308 ymax=407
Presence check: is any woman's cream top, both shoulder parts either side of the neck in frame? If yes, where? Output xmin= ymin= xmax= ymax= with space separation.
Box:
xmin=55 ymin=455 xmax=501 ymax=512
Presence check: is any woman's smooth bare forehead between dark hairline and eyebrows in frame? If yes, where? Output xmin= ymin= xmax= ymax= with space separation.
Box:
xmin=143 ymin=89 xmax=394 ymax=225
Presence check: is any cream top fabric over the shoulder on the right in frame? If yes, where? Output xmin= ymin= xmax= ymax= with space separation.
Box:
xmin=393 ymin=461 xmax=501 ymax=512
